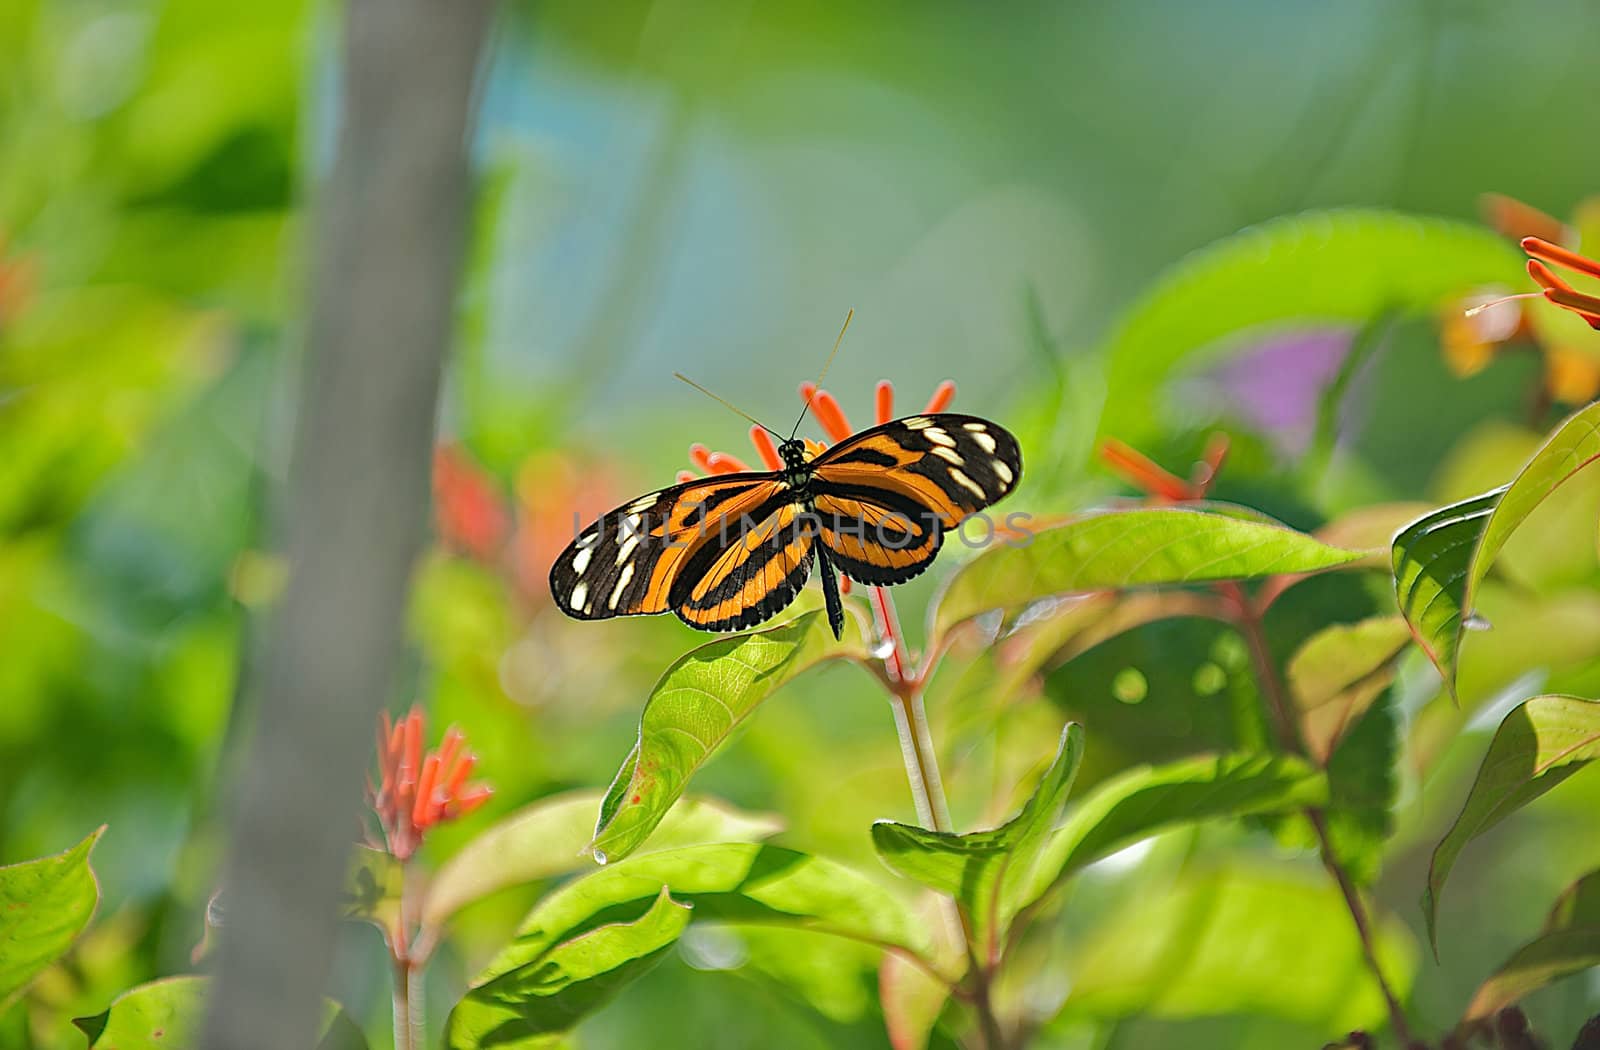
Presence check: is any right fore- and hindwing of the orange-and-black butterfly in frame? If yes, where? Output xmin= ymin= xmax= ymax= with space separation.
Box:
xmin=811 ymin=413 xmax=1022 ymax=584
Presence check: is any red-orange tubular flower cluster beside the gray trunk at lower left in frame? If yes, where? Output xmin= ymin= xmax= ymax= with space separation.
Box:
xmin=368 ymin=707 xmax=494 ymax=861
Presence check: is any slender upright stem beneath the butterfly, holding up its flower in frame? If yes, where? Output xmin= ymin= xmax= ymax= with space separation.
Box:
xmin=870 ymin=587 xmax=1006 ymax=1050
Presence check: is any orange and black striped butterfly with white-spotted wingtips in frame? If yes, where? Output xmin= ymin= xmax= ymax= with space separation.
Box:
xmin=550 ymin=409 xmax=1022 ymax=637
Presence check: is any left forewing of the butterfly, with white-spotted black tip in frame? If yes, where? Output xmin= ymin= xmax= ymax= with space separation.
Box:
xmin=550 ymin=472 xmax=803 ymax=629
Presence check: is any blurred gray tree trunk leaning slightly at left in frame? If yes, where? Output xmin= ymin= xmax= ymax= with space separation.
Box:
xmin=203 ymin=0 xmax=493 ymax=1050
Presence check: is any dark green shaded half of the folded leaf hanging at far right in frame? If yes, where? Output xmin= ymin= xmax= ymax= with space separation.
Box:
xmin=1392 ymin=488 xmax=1506 ymax=693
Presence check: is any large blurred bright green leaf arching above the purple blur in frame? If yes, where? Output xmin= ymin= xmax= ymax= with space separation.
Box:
xmin=1101 ymin=210 xmax=1525 ymax=442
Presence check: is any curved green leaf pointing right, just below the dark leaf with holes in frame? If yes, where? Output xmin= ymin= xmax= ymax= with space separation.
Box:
xmin=1026 ymin=754 xmax=1328 ymax=901
